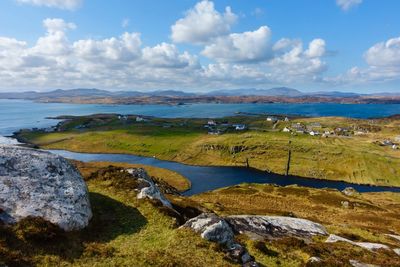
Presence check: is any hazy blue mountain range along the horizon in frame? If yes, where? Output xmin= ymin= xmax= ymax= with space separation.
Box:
xmin=0 ymin=87 xmax=400 ymax=100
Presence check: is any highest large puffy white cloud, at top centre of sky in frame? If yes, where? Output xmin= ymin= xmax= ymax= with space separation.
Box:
xmin=171 ymin=0 xmax=237 ymax=44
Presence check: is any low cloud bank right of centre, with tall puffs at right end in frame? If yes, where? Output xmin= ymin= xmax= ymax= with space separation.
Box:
xmin=204 ymin=39 xmax=327 ymax=87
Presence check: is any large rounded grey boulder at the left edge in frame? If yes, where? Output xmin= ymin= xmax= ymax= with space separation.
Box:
xmin=0 ymin=145 xmax=92 ymax=231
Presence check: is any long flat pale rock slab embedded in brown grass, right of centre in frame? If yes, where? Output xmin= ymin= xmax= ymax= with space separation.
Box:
xmin=225 ymin=215 xmax=328 ymax=241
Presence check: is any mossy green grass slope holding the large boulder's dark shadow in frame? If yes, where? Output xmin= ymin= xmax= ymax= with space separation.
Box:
xmin=0 ymin=164 xmax=230 ymax=267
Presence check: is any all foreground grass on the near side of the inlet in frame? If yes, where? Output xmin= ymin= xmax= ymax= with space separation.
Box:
xmin=0 ymin=162 xmax=400 ymax=267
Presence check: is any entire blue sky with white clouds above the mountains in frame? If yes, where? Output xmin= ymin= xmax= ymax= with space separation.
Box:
xmin=0 ymin=0 xmax=400 ymax=93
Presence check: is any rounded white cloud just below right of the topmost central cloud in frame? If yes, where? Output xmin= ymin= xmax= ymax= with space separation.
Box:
xmin=202 ymin=26 xmax=271 ymax=62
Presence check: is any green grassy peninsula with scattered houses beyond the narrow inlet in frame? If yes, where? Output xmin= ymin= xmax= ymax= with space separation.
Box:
xmin=20 ymin=116 xmax=400 ymax=186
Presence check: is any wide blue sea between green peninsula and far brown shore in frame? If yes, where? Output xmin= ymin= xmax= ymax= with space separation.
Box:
xmin=0 ymin=99 xmax=400 ymax=136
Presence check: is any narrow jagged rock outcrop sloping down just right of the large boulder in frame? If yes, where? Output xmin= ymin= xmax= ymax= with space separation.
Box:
xmin=127 ymin=168 xmax=172 ymax=209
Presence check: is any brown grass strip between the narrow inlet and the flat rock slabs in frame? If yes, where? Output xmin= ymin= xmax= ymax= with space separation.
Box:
xmin=191 ymin=184 xmax=400 ymax=237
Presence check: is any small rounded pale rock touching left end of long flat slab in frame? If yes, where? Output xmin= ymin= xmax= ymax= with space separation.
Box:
xmin=181 ymin=213 xmax=234 ymax=246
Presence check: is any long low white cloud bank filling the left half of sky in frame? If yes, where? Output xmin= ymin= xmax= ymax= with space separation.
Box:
xmin=0 ymin=19 xmax=201 ymax=89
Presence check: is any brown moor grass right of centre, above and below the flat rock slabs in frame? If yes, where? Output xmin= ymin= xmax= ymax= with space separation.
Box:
xmin=191 ymin=184 xmax=400 ymax=266
